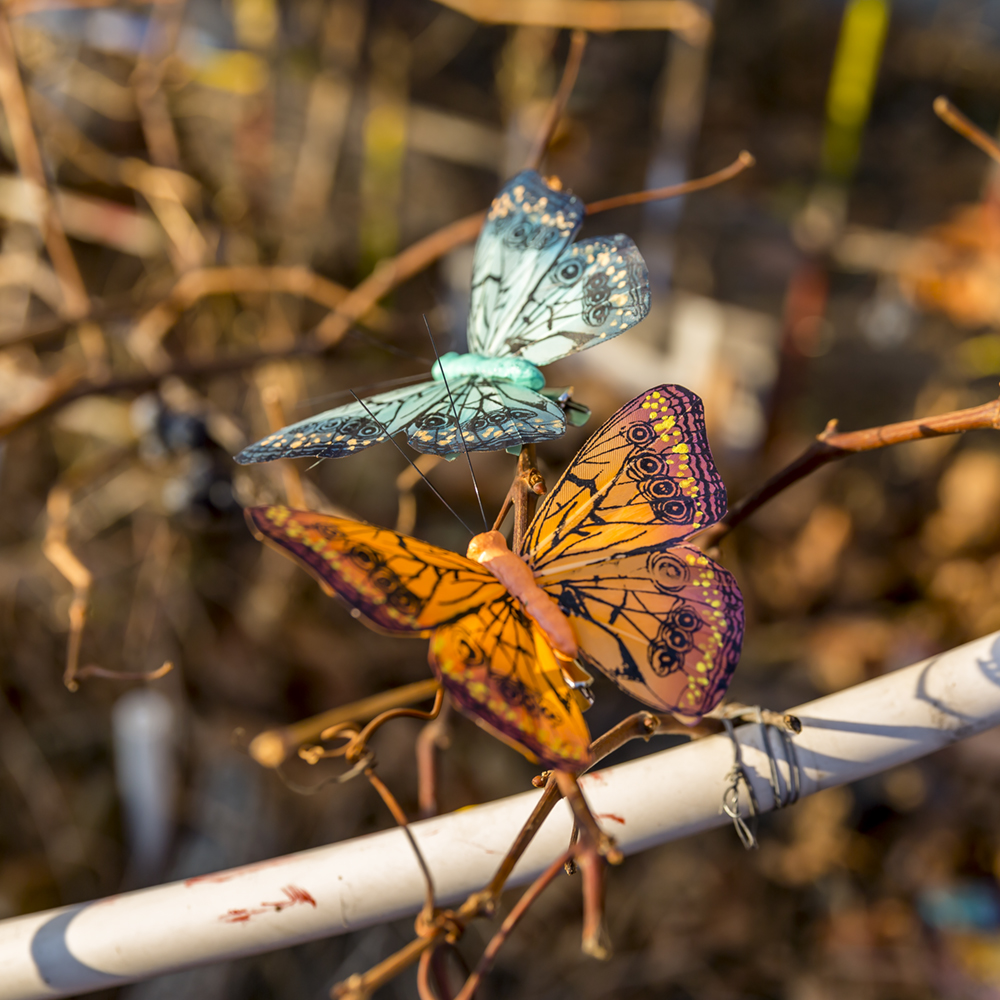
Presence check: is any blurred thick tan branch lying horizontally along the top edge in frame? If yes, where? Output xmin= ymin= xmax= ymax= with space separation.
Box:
xmin=438 ymin=0 xmax=712 ymax=45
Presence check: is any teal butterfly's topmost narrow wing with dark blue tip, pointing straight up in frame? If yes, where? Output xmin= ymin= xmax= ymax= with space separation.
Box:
xmin=469 ymin=170 xmax=584 ymax=356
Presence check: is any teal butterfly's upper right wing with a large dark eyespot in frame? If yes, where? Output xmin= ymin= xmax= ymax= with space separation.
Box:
xmin=497 ymin=235 xmax=650 ymax=365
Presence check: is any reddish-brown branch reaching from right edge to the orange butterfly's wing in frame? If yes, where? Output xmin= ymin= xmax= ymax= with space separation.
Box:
xmin=696 ymin=399 xmax=1000 ymax=549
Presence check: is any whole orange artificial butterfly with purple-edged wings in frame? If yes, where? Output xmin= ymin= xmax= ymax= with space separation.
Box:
xmin=247 ymin=385 xmax=743 ymax=770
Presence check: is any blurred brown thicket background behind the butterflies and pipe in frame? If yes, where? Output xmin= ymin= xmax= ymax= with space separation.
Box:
xmin=0 ymin=0 xmax=1000 ymax=1000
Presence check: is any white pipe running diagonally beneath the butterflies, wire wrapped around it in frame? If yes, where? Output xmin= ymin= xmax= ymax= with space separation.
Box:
xmin=0 ymin=633 xmax=1000 ymax=1000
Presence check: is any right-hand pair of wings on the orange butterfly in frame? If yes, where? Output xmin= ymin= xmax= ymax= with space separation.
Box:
xmin=524 ymin=385 xmax=743 ymax=717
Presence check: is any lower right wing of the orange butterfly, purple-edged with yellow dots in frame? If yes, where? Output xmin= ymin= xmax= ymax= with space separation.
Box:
xmin=545 ymin=544 xmax=743 ymax=718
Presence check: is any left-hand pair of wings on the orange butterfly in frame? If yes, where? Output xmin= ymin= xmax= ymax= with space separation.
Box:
xmin=246 ymin=507 xmax=590 ymax=770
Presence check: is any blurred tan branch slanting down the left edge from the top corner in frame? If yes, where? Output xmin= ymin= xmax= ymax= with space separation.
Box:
xmin=0 ymin=13 xmax=89 ymax=317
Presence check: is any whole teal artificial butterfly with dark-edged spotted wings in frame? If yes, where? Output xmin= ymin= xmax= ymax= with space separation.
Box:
xmin=236 ymin=170 xmax=649 ymax=465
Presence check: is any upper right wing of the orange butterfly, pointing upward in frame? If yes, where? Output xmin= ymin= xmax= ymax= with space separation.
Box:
xmin=523 ymin=385 xmax=726 ymax=572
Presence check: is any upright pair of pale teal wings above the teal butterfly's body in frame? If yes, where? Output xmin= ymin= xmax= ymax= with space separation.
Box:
xmin=469 ymin=170 xmax=650 ymax=365
